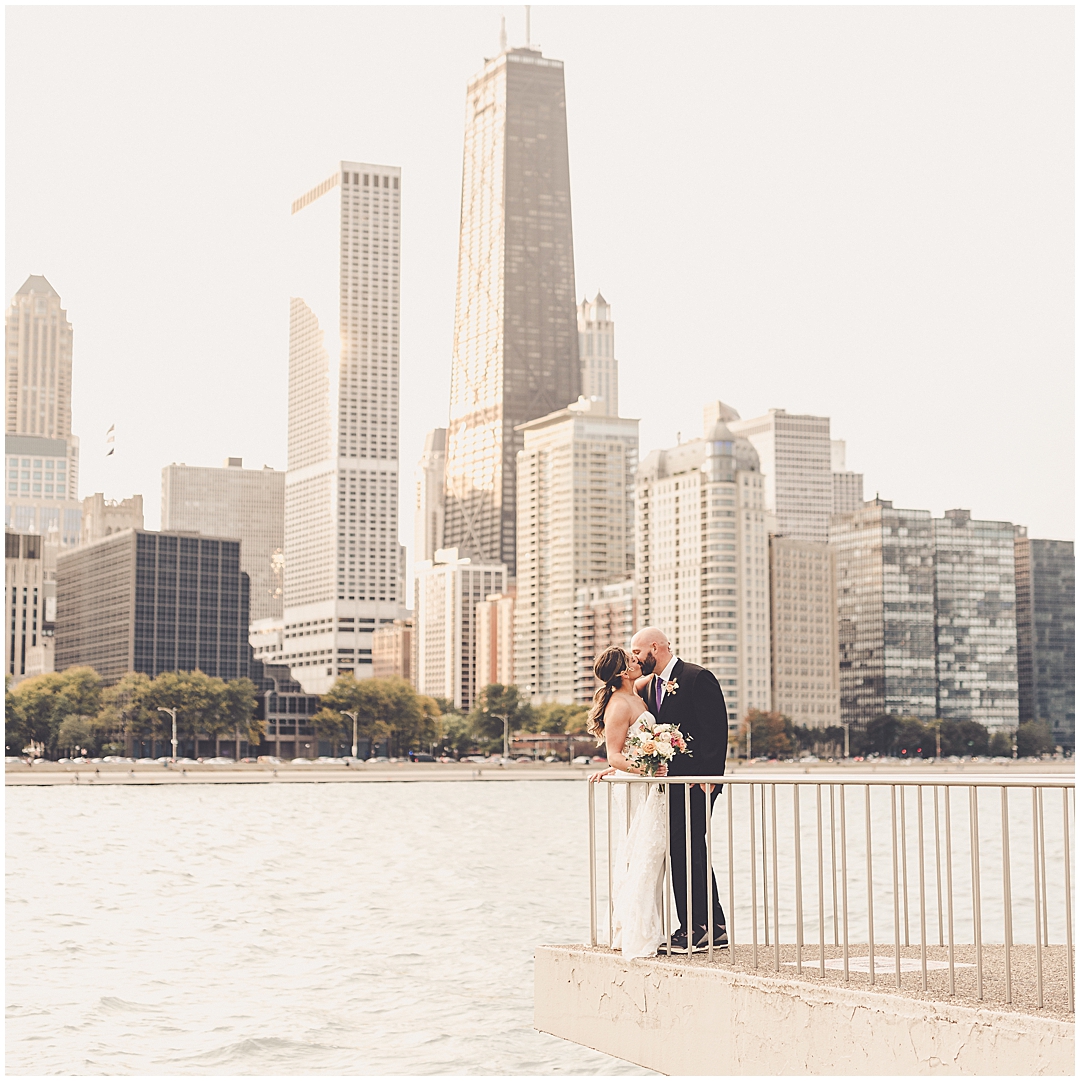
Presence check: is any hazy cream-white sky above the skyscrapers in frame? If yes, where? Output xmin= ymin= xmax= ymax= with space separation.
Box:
xmin=5 ymin=6 xmax=1074 ymax=548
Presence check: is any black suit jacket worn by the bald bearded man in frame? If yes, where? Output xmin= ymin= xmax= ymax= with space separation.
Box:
xmin=645 ymin=659 xmax=728 ymax=777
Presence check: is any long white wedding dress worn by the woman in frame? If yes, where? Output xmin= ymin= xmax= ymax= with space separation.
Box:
xmin=612 ymin=710 xmax=667 ymax=958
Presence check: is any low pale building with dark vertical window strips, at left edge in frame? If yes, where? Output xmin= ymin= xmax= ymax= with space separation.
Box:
xmin=3 ymin=530 xmax=58 ymax=683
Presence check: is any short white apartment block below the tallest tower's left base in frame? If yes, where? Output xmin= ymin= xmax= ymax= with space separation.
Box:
xmin=416 ymin=548 xmax=506 ymax=711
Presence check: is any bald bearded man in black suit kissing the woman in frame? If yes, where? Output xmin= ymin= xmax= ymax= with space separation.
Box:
xmin=630 ymin=627 xmax=728 ymax=953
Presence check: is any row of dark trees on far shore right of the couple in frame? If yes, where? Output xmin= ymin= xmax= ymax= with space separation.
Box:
xmin=732 ymin=709 xmax=1054 ymax=758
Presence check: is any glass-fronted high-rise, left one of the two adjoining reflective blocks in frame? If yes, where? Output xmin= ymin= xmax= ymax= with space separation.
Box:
xmin=829 ymin=498 xmax=937 ymax=724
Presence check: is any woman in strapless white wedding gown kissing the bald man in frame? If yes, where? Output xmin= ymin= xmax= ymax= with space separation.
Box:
xmin=588 ymin=645 xmax=667 ymax=958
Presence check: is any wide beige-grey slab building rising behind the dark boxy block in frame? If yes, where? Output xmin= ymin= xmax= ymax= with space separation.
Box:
xmin=161 ymin=458 xmax=285 ymax=623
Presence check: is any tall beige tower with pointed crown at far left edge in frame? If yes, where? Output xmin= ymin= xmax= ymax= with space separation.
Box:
xmin=4 ymin=275 xmax=81 ymax=547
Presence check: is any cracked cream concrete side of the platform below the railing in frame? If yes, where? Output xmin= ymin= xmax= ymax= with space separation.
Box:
xmin=534 ymin=946 xmax=1076 ymax=1076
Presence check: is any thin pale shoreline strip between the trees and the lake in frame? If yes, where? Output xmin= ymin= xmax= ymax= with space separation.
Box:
xmin=4 ymin=759 xmax=1075 ymax=787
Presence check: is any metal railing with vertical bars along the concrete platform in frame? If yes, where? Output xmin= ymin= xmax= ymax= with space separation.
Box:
xmin=588 ymin=773 xmax=1076 ymax=1013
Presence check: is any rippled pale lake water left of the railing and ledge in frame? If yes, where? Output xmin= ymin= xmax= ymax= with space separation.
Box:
xmin=6 ymin=782 xmax=645 ymax=1073
